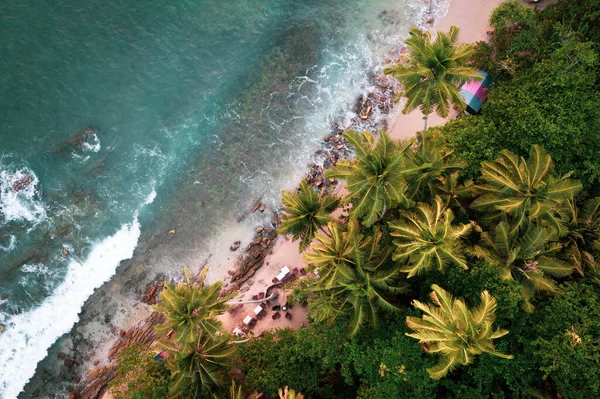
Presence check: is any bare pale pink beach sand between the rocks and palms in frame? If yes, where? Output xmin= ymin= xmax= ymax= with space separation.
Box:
xmin=95 ymin=0 xmax=510 ymax=399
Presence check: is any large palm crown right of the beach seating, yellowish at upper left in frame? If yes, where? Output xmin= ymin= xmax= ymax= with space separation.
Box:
xmin=305 ymin=219 xmax=406 ymax=335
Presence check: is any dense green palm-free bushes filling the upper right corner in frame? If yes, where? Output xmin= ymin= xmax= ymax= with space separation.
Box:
xmin=440 ymin=0 xmax=600 ymax=190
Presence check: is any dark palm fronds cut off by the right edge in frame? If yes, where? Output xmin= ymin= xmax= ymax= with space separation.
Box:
xmin=561 ymin=198 xmax=600 ymax=283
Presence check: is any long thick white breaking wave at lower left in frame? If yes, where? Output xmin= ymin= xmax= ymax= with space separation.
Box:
xmin=0 ymin=189 xmax=156 ymax=399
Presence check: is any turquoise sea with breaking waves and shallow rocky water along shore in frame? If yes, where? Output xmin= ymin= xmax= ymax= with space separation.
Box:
xmin=0 ymin=0 xmax=442 ymax=398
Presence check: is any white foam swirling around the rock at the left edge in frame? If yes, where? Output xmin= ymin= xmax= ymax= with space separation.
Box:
xmin=0 ymin=164 xmax=46 ymax=224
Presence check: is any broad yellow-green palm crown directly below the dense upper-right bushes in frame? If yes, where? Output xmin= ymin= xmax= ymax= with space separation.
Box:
xmin=471 ymin=145 xmax=581 ymax=236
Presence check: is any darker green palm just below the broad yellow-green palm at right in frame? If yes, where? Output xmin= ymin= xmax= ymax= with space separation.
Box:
xmin=472 ymin=222 xmax=573 ymax=313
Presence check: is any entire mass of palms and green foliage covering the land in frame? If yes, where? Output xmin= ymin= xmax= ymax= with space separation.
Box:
xmin=118 ymin=0 xmax=600 ymax=399
